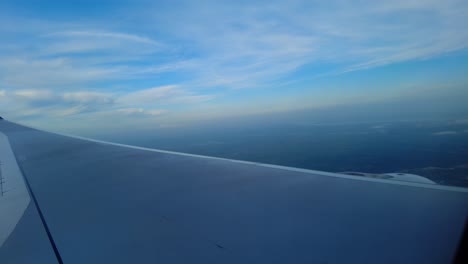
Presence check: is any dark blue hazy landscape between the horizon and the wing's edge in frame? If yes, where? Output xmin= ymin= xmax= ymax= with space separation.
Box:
xmin=101 ymin=104 xmax=468 ymax=187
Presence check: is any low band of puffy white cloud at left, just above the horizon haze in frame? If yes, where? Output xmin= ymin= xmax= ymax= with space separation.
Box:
xmin=0 ymin=85 xmax=212 ymax=121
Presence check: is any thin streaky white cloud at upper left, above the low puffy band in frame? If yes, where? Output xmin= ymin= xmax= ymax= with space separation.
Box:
xmin=0 ymin=27 xmax=170 ymax=89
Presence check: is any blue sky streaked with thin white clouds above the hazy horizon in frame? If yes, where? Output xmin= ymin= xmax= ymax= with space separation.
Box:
xmin=0 ymin=0 xmax=468 ymax=134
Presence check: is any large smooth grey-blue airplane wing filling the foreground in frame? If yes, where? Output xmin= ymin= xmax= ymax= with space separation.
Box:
xmin=0 ymin=120 xmax=468 ymax=263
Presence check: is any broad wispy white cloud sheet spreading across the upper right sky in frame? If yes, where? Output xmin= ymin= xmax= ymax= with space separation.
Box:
xmin=137 ymin=0 xmax=468 ymax=84
